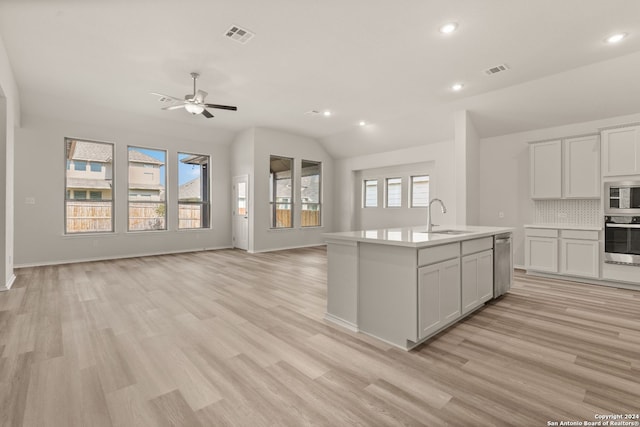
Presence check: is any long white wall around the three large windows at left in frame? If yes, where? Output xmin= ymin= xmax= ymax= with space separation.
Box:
xmin=15 ymin=114 xmax=231 ymax=266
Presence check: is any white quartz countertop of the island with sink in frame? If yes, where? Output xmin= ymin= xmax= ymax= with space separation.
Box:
xmin=324 ymin=225 xmax=514 ymax=248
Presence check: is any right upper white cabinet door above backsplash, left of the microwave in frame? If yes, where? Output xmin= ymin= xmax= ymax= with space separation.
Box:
xmin=563 ymin=135 xmax=600 ymax=198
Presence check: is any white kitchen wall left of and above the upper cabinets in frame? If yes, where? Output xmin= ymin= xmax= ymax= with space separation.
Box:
xmin=478 ymin=110 xmax=640 ymax=266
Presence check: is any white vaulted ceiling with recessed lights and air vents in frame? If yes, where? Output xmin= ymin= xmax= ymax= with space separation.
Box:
xmin=0 ymin=0 xmax=640 ymax=157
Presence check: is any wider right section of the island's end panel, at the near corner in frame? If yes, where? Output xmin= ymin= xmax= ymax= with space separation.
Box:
xmin=358 ymin=243 xmax=418 ymax=349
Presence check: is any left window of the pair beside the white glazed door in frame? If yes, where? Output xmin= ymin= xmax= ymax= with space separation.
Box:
xmin=269 ymin=156 xmax=293 ymax=228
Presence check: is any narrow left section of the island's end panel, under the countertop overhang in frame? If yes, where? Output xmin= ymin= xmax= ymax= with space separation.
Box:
xmin=326 ymin=240 xmax=358 ymax=331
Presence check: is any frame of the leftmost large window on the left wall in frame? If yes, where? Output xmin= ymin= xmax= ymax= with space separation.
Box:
xmin=62 ymin=137 xmax=116 ymax=236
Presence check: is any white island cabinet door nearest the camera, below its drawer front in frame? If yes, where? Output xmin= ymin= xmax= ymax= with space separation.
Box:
xmin=418 ymin=258 xmax=460 ymax=339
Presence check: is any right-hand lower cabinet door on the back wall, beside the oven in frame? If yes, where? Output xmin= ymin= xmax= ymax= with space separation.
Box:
xmin=560 ymin=239 xmax=600 ymax=277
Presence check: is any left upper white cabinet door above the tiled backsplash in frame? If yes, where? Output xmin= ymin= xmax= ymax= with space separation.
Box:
xmin=529 ymin=140 xmax=562 ymax=199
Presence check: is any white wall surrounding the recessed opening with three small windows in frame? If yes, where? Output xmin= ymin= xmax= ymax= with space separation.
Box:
xmin=335 ymin=141 xmax=457 ymax=231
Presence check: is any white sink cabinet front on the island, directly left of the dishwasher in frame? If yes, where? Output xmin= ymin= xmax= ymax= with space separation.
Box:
xmin=462 ymin=249 xmax=493 ymax=314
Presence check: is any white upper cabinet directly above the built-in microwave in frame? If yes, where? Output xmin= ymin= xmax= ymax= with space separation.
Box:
xmin=602 ymin=126 xmax=640 ymax=176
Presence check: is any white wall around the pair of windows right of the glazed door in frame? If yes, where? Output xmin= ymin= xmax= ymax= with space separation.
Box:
xmin=249 ymin=128 xmax=334 ymax=252
